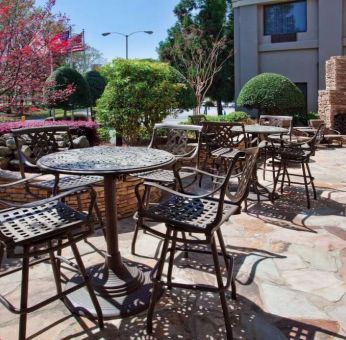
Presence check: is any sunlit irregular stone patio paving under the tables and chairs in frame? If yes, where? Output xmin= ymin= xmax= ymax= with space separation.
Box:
xmin=0 ymin=148 xmax=346 ymax=340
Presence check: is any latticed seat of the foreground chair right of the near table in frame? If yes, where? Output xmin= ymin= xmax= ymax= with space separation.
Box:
xmin=142 ymin=196 xmax=240 ymax=233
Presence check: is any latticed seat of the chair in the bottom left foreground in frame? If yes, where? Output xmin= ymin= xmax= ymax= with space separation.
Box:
xmin=0 ymin=201 xmax=87 ymax=246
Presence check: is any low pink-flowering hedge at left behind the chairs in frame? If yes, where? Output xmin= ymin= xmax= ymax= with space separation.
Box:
xmin=0 ymin=120 xmax=100 ymax=145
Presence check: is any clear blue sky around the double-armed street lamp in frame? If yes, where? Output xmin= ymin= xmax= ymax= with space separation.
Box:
xmin=36 ymin=0 xmax=179 ymax=61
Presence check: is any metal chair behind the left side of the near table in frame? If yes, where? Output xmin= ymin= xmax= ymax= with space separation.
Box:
xmin=12 ymin=126 xmax=103 ymax=226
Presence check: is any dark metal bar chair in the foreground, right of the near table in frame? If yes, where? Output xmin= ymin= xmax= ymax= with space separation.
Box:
xmin=136 ymin=148 xmax=258 ymax=339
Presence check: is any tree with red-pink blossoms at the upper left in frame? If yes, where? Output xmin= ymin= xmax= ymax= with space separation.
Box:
xmin=0 ymin=0 xmax=69 ymax=113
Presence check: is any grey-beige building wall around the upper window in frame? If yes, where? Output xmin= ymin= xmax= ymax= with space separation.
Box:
xmin=233 ymin=0 xmax=346 ymax=112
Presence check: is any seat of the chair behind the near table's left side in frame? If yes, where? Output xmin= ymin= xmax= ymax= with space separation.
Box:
xmin=30 ymin=176 xmax=103 ymax=191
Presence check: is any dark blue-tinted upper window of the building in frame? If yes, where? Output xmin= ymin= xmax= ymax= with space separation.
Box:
xmin=264 ymin=0 xmax=307 ymax=35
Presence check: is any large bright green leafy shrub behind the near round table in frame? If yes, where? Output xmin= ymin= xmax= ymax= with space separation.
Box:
xmin=96 ymin=59 xmax=195 ymax=143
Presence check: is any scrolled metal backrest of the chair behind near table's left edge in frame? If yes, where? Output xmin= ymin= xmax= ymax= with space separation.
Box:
xmin=12 ymin=126 xmax=73 ymax=177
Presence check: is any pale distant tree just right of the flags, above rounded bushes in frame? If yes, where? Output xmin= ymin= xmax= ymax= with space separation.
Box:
xmin=71 ymin=45 xmax=106 ymax=73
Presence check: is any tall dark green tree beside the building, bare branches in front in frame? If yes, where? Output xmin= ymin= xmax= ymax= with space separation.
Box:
xmin=158 ymin=0 xmax=234 ymax=114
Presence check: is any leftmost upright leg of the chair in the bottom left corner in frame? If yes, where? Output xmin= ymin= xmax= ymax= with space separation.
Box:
xmin=18 ymin=247 xmax=29 ymax=340
